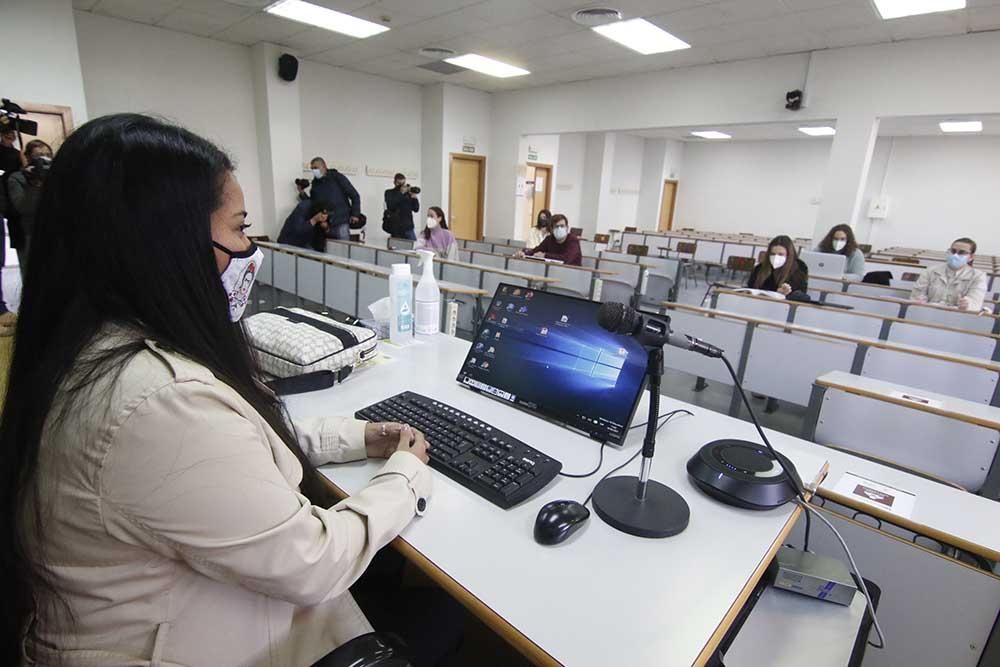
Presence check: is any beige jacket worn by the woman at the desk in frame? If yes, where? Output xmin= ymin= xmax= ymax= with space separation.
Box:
xmin=25 ymin=341 xmax=431 ymax=667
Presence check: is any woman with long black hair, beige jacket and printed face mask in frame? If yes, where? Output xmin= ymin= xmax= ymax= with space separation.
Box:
xmin=0 ymin=114 xmax=431 ymax=666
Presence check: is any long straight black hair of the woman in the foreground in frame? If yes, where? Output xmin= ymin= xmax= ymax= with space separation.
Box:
xmin=0 ymin=114 xmax=334 ymax=665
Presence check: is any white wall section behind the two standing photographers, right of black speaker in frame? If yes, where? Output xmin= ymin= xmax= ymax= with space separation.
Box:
xmin=298 ymin=60 xmax=420 ymax=247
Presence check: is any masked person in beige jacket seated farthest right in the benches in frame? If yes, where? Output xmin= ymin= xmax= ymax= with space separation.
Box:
xmin=910 ymin=237 xmax=987 ymax=311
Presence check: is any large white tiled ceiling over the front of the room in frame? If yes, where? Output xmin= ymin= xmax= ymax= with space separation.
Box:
xmin=73 ymin=0 xmax=1000 ymax=91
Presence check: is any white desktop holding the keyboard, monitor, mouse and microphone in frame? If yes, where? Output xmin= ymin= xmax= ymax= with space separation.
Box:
xmin=286 ymin=336 xmax=825 ymax=667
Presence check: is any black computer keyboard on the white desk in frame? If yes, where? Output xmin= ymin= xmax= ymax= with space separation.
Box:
xmin=357 ymin=391 xmax=562 ymax=509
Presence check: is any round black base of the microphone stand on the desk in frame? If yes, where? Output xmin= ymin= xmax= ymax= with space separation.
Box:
xmin=593 ymin=477 xmax=691 ymax=538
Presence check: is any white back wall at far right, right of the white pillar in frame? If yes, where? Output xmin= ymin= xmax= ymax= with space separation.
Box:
xmin=864 ymin=136 xmax=1000 ymax=254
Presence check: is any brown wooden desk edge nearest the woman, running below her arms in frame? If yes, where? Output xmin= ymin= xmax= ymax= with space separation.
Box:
xmin=320 ymin=471 xmax=563 ymax=667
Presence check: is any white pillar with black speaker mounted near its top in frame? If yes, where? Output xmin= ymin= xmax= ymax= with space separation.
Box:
xmin=251 ymin=43 xmax=306 ymax=238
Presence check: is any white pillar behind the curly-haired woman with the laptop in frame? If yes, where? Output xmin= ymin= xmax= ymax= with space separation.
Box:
xmin=813 ymin=112 xmax=879 ymax=241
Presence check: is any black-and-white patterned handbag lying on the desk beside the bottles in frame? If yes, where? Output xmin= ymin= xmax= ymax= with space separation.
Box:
xmin=245 ymin=308 xmax=378 ymax=380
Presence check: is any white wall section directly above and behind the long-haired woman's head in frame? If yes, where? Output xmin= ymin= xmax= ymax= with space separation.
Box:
xmin=74 ymin=12 xmax=270 ymax=224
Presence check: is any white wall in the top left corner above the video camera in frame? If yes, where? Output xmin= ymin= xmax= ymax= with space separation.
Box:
xmin=0 ymin=0 xmax=88 ymax=127
